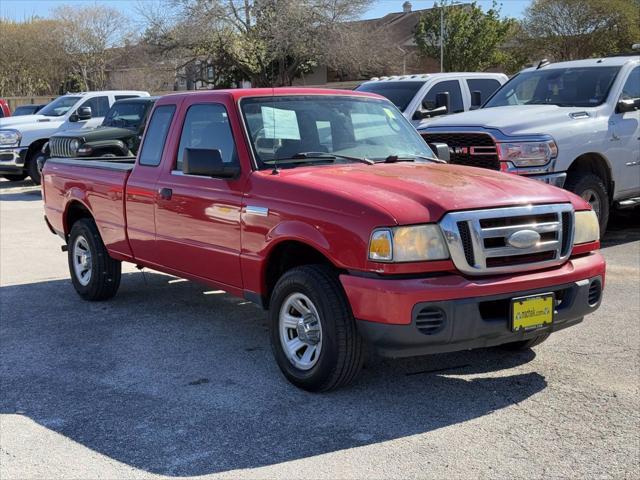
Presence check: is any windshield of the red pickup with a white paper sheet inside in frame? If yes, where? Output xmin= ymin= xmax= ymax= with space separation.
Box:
xmin=240 ymin=95 xmax=435 ymax=168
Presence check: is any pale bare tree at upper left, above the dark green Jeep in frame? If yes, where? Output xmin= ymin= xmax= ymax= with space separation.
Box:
xmin=54 ymin=5 xmax=129 ymax=90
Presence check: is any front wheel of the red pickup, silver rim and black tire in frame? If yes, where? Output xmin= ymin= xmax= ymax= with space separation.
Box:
xmin=269 ymin=265 xmax=365 ymax=392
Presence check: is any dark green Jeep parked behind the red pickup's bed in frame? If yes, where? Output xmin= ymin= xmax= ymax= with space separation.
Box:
xmin=38 ymin=97 xmax=158 ymax=162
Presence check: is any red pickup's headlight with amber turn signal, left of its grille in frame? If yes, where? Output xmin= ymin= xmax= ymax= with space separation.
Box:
xmin=369 ymin=225 xmax=449 ymax=262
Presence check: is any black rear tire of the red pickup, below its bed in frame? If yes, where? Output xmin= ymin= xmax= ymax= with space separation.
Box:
xmin=68 ymin=218 xmax=121 ymax=301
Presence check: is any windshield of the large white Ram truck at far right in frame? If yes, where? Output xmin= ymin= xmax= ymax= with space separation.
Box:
xmin=483 ymin=67 xmax=620 ymax=108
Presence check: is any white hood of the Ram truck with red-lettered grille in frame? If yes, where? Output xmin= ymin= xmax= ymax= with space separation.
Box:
xmin=421 ymin=105 xmax=593 ymax=136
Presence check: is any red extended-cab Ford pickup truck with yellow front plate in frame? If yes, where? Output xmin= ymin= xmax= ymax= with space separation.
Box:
xmin=43 ymin=89 xmax=605 ymax=391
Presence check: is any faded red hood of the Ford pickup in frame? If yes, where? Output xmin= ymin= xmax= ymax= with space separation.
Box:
xmin=279 ymin=162 xmax=589 ymax=225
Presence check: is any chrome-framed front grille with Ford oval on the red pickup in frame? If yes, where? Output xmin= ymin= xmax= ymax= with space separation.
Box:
xmin=440 ymin=204 xmax=573 ymax=275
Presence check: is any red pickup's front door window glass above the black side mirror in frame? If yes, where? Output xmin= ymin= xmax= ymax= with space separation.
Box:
xmin=176 ymin=103 xmax=238 ymax=170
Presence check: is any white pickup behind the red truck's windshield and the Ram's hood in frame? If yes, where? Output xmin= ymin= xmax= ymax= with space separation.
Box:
xmin=356 ymin=72 xmax=507 ymax=128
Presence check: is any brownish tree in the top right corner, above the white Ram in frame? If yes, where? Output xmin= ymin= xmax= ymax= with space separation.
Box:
xmin=523 ymin=0 xmax=640 ymax=61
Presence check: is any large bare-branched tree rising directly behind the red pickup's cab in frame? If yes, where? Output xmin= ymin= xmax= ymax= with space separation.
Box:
xmin=145 ymin=0 xmax=378 ymax=86
